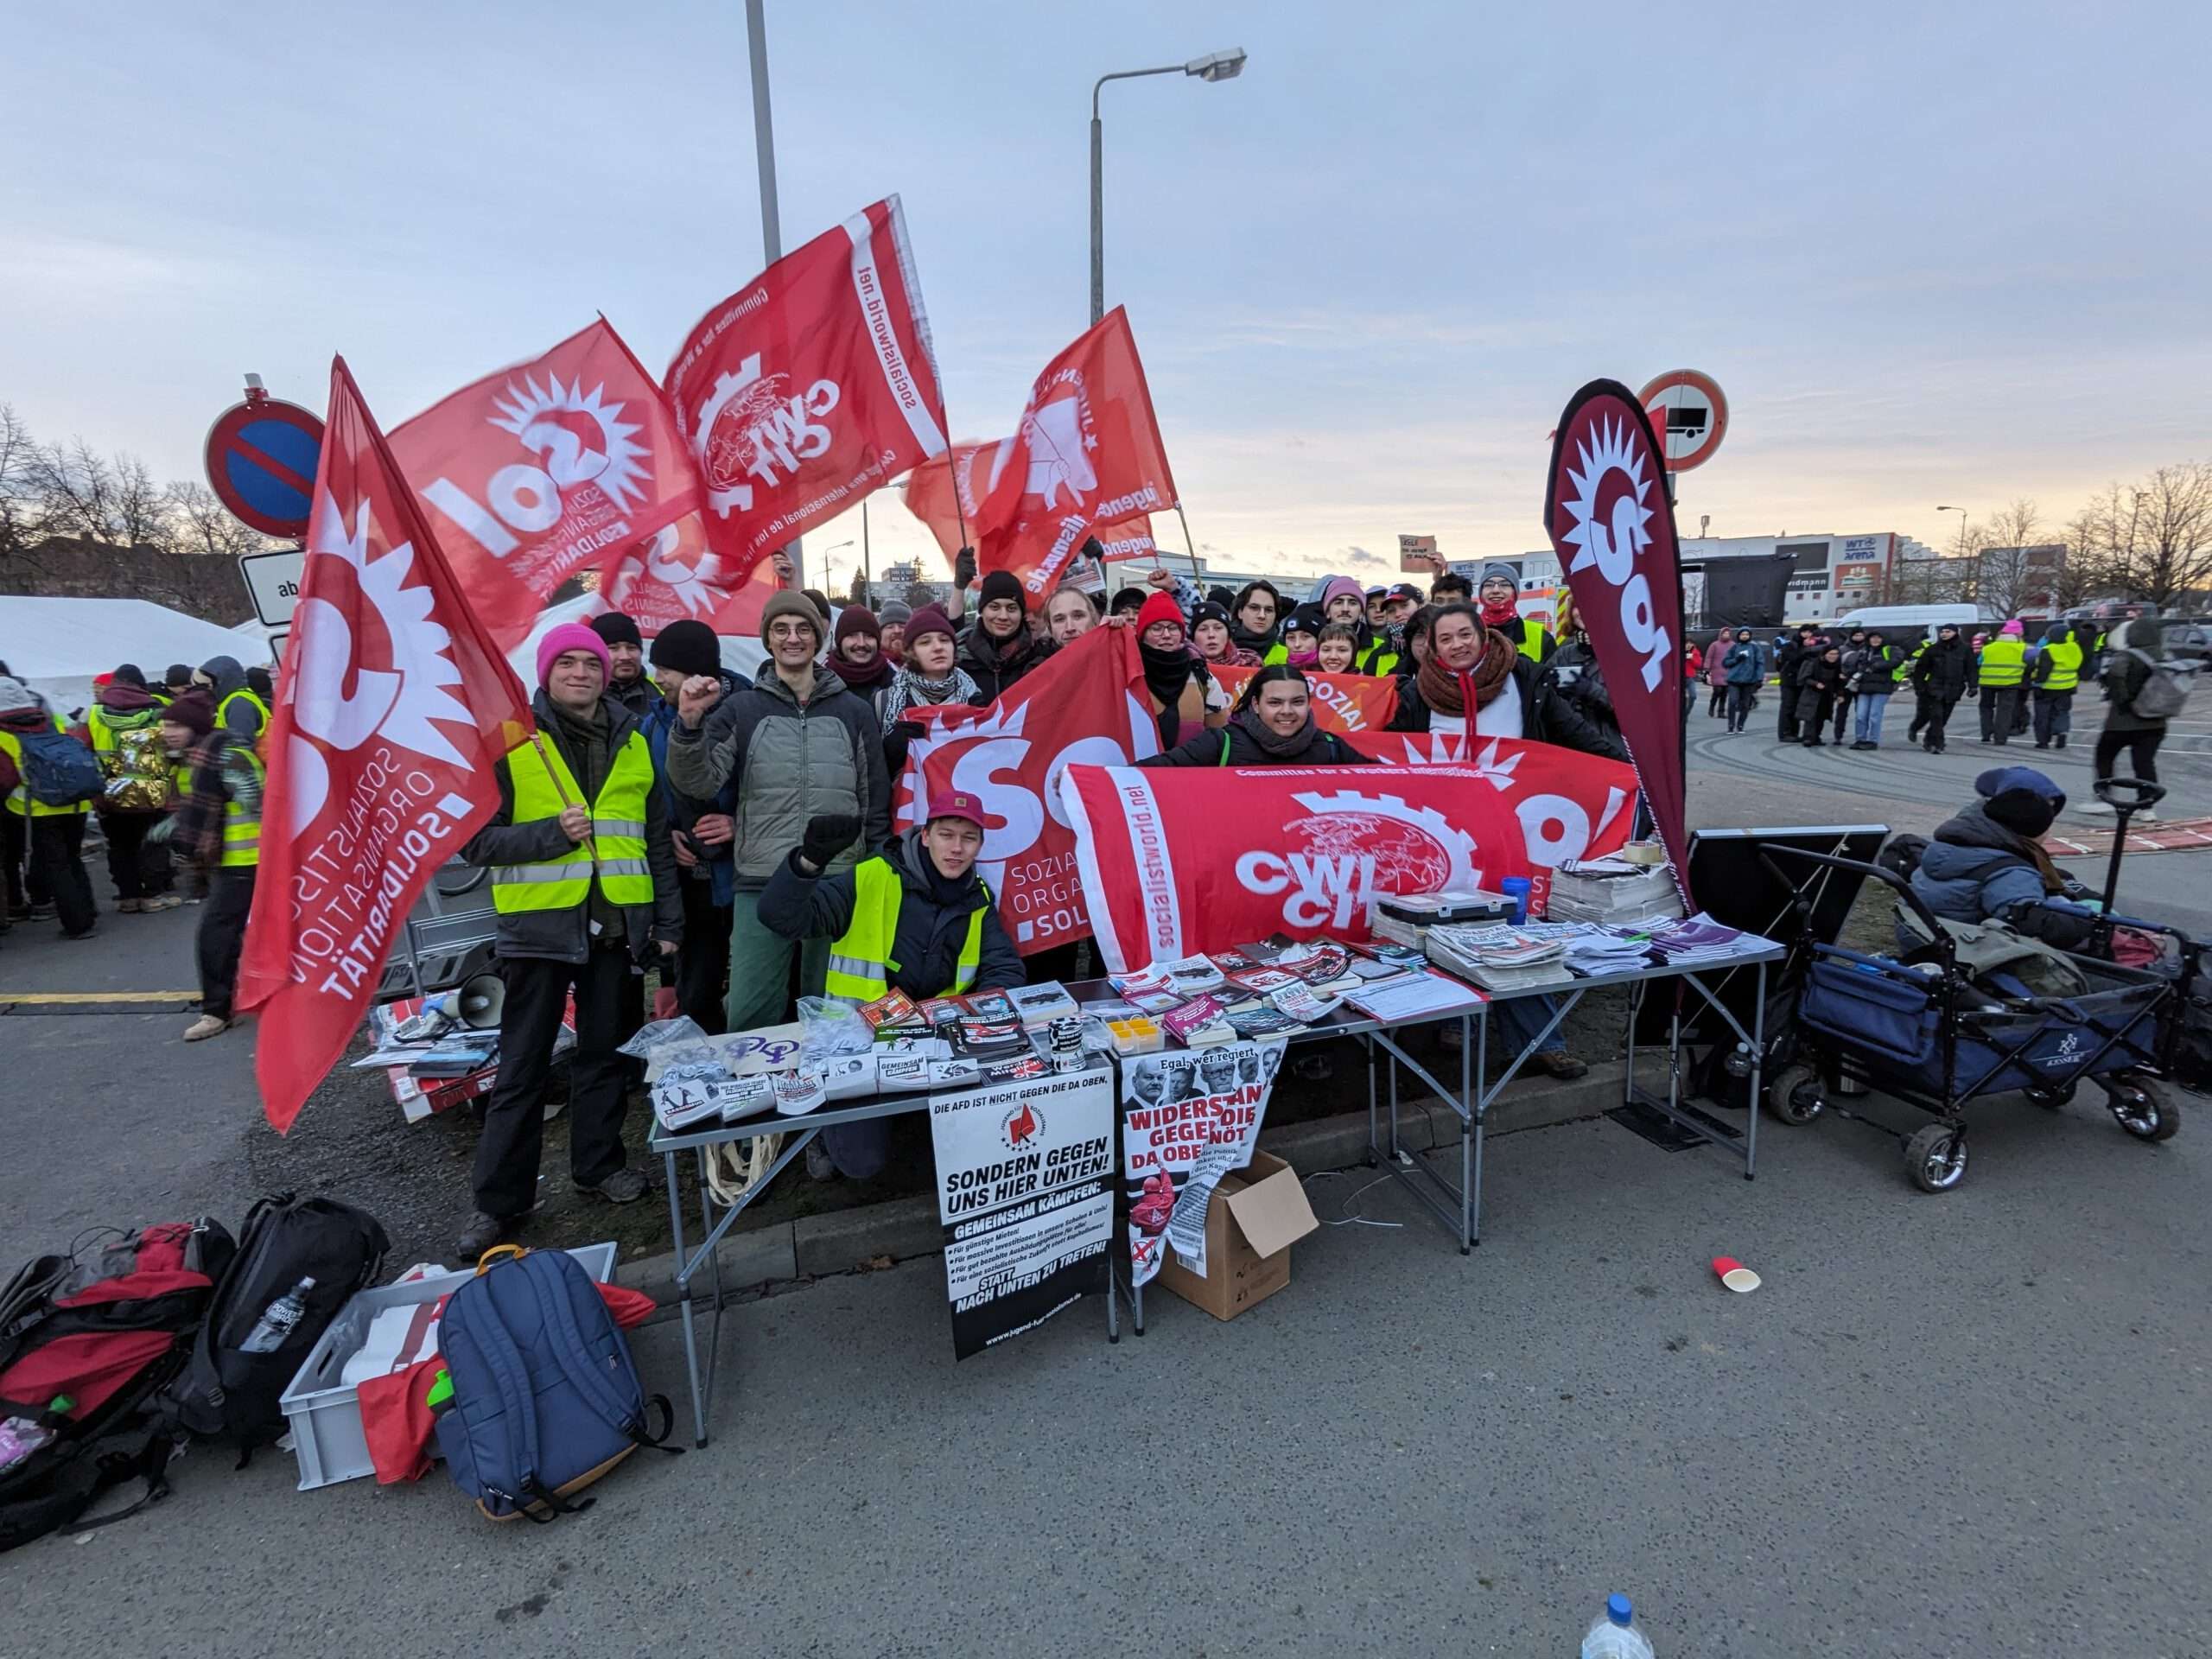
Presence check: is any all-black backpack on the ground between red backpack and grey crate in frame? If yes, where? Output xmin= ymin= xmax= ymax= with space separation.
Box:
xmin=162 ymin=1192 xmax=391 ymax=1469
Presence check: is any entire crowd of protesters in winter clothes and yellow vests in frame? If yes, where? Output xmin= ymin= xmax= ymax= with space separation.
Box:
xmin=0 ymin=550 xmax=2164 ymax=1256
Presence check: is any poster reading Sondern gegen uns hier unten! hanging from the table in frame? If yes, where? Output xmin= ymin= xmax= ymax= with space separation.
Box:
xmin=929 ymin=1068 xmax=1115 ymax=1360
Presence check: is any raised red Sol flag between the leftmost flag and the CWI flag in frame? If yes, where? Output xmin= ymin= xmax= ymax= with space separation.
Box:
xmin=391 ymin=319 xmax=699 ymax=648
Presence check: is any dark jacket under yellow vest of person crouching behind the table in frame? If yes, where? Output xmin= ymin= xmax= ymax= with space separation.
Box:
xmin=761 ymin=830 xmax=1028 ymax=1000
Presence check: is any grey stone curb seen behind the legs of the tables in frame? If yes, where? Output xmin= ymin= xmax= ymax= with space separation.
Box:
xmin=615 ymin=1059 xmax=1628 ymax=1323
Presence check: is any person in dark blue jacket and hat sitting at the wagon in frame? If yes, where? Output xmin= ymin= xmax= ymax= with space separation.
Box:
xmin=1900 ymin=766 xmax=2097 ymax=951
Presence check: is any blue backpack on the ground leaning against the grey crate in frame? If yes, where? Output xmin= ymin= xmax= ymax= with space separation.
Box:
xmin=438 ymin=1249 xmax=681 ymax=1522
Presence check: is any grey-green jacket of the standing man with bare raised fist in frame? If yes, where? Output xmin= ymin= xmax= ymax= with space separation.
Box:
xmin=668 ymin=668 xmax=892 ymax=893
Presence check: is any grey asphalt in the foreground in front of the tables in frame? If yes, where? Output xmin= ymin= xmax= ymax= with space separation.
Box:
xmin=0 ymin=1106 xmax=2212 ymax=1659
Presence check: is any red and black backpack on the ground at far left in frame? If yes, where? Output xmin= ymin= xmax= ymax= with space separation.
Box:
xmin=0 ymin=1217 xmax=237 ymax=1551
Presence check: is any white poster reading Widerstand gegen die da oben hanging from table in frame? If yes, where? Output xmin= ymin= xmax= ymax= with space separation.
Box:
xmin=1122 ymin=1039 xmax=1285 ymax=1285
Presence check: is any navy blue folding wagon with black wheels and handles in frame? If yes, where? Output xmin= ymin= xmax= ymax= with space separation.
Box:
xmin=1763 ymin=779 xmax=2201 ymax=1192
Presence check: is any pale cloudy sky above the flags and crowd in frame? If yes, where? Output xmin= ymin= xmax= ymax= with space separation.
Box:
xmin=0 ymin=0 xmax=2212 ymax=584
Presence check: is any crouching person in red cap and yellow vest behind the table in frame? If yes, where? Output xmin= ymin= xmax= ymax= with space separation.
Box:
xmin=761 ymin=790 xmax=1027 ymax=1181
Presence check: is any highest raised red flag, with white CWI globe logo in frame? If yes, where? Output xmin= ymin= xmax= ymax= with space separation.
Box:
xmin=664 ymin=197 xmax=944 ymax=582
